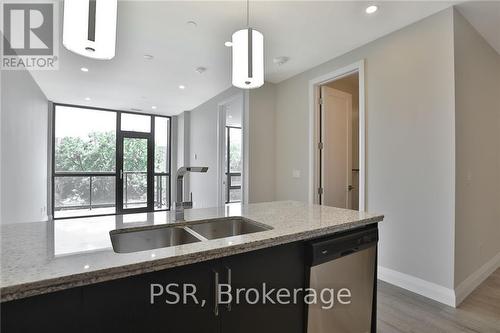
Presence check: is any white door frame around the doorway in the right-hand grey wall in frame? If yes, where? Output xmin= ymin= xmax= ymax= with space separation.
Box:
xmin=309 ymin=59 xmax=366 ymax=211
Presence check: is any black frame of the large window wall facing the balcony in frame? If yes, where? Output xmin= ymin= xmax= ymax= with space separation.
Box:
xmin=50 ymin=102 xmax=172 ymax=220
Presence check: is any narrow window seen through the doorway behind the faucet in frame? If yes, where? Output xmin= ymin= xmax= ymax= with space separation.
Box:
xmin=226 ymin=126 xmax=242 ymax=203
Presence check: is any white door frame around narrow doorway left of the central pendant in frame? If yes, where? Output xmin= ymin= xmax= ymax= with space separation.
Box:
xmin=217 ymin=92 xmax=249 ymax=207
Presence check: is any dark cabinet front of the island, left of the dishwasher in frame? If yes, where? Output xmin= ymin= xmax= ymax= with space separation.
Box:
xmin=1 ymin=243 xmax=305 ymax=333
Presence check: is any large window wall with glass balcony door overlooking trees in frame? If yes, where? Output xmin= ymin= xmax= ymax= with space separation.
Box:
xmin=52 ymin=105 xmax=171 ymax=218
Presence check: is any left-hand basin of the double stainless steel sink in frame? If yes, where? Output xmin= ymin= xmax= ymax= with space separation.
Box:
xmin=110 ymin=226 xmax=200 ymax=253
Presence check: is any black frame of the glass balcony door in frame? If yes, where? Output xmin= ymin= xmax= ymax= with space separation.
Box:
xmin=115 ymin=128 xmax=154 ymax=214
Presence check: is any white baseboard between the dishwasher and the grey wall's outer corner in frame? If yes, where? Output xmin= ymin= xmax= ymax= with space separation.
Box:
xmin=378 ymin=266 xmax=456 ymax=307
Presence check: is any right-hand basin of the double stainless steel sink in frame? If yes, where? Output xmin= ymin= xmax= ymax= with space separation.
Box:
xmin=187 ymin=217 xmax=272 ymax=239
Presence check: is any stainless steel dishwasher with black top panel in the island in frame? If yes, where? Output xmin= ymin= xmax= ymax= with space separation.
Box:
xmin=307 ymin=225 xmax=378 ymax=333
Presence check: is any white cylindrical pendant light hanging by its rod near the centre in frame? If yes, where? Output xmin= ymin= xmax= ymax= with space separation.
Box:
xmin=232 ymin=0 xmax=264 ymax=89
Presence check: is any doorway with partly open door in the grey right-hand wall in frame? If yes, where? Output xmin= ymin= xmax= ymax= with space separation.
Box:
xmin=310 ymin=62 xmax=365 ymax=210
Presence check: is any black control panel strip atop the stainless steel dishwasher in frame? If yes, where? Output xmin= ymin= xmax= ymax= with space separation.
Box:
xmin=309 ymin=227 xmax=378 ymax=266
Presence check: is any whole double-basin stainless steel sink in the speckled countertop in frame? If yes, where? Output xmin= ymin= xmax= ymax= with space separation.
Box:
xmin=109 ymin=216 xmax=272 ymax=253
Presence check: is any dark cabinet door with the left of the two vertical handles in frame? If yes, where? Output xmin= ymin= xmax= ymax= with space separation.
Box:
xmin=82 ymin=262 xmax=218 ymax=333
